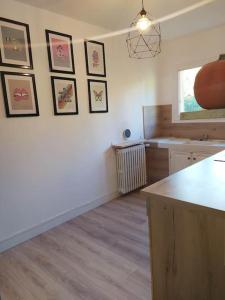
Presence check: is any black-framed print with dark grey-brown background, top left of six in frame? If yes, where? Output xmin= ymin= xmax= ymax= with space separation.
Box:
xmin=0 ymin=18 xmax=33 ymax=69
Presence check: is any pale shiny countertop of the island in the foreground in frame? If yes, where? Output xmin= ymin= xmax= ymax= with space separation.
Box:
xmin=143 ymin=151 xmax=225 ymax=217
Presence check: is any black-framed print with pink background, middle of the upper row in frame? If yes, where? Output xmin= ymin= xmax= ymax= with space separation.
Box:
xmin=45 ymin=30 xmax=75 ymax=74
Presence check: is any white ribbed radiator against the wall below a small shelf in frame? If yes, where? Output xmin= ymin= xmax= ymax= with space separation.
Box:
xmin=116 ymin=145 xmax=146 ymax=194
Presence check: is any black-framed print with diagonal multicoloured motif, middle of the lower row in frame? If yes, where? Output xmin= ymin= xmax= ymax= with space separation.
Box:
xmin=51 ymin=76 xmax=78 ymax=115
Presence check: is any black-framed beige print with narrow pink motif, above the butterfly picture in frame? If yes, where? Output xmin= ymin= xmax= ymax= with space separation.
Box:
xmin=84 ymin=41 xmax=106 ymax=77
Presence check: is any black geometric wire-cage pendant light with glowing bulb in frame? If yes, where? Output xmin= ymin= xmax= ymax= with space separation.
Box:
xmin=126 ymin=0 xmax=161 ymax=59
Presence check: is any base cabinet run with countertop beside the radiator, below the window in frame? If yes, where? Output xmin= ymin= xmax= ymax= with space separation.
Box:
xmin=146 ymin=137 xmax=225 ymax=184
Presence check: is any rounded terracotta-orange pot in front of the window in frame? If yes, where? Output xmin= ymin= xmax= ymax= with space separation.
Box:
xmin=194 ymin=56 xmax=225 ymax=109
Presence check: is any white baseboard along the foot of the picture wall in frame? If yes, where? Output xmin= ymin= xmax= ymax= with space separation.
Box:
xmin=0 ymin=192 xmax=119 ymax=253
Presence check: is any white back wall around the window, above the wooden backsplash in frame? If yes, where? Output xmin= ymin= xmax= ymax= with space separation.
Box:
xmin=157 ymin=25 xmax=225 ymax=120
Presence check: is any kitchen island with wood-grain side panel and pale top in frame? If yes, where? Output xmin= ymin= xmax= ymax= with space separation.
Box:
xmin=143 ymin=151 xmax=225 ymax=300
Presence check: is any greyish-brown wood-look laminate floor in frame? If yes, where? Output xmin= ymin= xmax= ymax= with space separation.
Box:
xmin=0 ymin=193 xmax=150 ymax=300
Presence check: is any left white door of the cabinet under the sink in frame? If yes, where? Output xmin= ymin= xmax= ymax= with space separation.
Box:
xmin=170 ymin=151 xmax=192 ymax=174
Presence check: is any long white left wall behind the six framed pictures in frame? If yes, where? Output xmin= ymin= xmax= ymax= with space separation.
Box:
xmin=0 ymin=0 xmax=157 ymax=250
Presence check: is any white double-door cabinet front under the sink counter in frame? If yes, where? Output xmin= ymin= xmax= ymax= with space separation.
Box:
xmin=169 ymin=150 xmax=216 ymax=174
